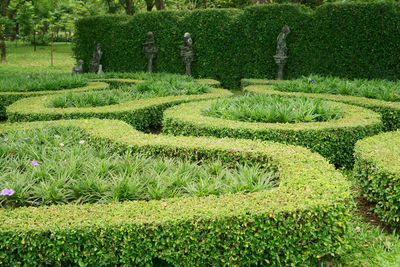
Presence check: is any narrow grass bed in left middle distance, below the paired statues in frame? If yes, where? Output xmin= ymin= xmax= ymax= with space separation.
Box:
xmin=49 ymin=78 xmax=210 ymax=108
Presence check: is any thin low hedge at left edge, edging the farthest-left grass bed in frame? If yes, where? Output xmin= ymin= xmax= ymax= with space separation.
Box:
xmin=0 ymin=82 xmax=109 ymax=120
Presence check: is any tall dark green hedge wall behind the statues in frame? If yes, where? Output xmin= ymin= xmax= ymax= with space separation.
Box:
xmin=75 ymin=3 xmax=400 ymax=87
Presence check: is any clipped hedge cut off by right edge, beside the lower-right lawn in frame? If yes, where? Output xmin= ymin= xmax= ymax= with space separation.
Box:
xmin=354 ymin=131 xmax=400 ymax=230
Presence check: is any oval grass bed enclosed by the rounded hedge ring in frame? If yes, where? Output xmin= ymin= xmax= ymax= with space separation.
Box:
xmin=203 ymin=94 xmax=343 ymax=123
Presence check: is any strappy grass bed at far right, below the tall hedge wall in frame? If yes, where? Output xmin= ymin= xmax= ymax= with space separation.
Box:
xmin=272 ymin=75 xmax=400 ymax=102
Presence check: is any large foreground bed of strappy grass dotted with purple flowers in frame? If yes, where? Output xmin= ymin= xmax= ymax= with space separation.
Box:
xmin=0 ymin=128 xmax=277 ymax=207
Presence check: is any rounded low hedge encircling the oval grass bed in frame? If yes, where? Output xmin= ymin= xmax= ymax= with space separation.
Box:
xmin=163 ymin=101 xmax=382 ymax=167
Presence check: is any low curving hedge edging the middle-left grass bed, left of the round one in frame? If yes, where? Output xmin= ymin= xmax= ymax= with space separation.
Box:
xmin=7 ymin=88 xmax=232 ymax=131
